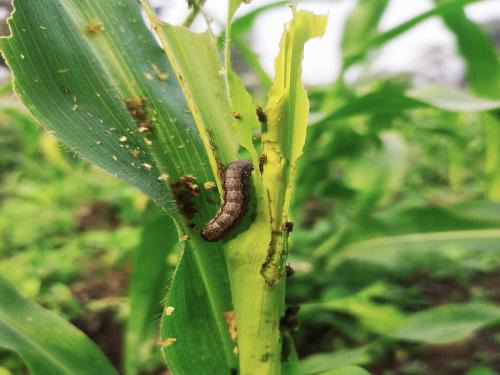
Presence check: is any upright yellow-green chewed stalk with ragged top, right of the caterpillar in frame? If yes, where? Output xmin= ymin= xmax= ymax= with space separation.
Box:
xmin=231 ymin=9 xmax=326 ymax=375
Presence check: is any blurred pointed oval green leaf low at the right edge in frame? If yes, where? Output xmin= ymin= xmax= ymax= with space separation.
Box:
xmin=391 ymin=303 xmax=500 ymax=345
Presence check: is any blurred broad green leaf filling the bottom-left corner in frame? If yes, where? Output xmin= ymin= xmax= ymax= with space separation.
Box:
xmin=0 ymin=278 xmax=116 ymax=375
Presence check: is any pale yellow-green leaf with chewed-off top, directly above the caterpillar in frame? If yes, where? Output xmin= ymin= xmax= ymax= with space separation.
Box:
xmin=138 ymin=1 xmax=237 ymax=187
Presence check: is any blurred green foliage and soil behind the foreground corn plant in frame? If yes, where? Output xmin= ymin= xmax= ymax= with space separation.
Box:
xmin=0 ymin=0 xmax=500 ymax=375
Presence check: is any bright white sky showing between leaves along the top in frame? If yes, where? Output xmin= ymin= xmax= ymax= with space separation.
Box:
xmin=152 ymin=0 xmax=500 ymax=85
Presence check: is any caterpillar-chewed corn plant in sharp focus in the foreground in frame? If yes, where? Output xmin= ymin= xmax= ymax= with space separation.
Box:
xmin=0 ymin=0 xmax=326 ymax=374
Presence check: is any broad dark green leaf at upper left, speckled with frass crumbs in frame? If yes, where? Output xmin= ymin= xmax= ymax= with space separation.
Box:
xmin=0 ymin=0 xmax=204 ymax=211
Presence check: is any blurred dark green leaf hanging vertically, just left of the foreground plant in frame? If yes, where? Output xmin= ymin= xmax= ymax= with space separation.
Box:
xmin=125 ymin=206 xmax=178 ymax=374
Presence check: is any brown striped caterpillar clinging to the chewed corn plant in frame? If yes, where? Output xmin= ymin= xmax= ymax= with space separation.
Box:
xmin=201 ymin=160 xmax=253 ymax=242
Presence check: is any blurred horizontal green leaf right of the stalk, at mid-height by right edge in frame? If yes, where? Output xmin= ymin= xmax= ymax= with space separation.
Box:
xmin=314 ymin=201 xmax=500 ymax=267
